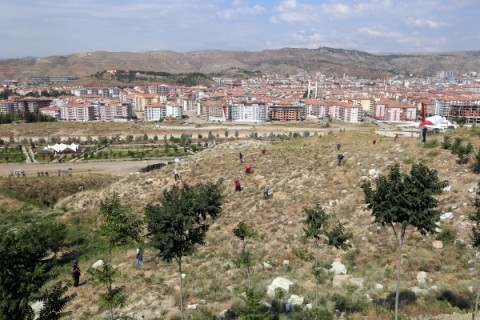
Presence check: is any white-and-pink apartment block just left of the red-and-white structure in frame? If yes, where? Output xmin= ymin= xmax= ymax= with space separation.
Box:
xmin=372 ymin=101 xmax=417 ymax=122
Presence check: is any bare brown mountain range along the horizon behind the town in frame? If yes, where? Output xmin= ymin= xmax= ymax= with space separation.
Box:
xmin=0 ymin=47 xmax=480 ymax=81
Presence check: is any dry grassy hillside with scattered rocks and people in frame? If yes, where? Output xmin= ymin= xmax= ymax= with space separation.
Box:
xmin=40 ymin=129 xmax=480 ymax=319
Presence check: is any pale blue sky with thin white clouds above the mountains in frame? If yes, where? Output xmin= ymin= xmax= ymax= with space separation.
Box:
xmin=0 ymin=0 xmax=480 ymax=59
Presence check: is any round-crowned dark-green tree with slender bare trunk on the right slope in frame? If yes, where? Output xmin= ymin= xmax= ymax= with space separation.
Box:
xmin=362 ymin=163 xmax=448 ymax=320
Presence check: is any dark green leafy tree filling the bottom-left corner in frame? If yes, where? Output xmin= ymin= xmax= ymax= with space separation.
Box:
xmin=0 ymin=223 xmax=73 ymax=320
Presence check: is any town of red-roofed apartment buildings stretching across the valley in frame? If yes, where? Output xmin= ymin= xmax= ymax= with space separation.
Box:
xmin=0 ymin=71 xmax=480 ymax=123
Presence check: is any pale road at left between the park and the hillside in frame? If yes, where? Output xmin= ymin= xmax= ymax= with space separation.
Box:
xmin=0 ymin=160 xmax=169 ymax=177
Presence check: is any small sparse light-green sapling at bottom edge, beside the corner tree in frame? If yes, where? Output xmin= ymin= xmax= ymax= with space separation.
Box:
xmin=87 ymin=263 xmax=127 ymax=320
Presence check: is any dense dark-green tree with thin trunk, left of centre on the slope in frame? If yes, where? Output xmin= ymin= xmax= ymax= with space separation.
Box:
xmin=145 ymin=180 xmax=223 ymax=320
